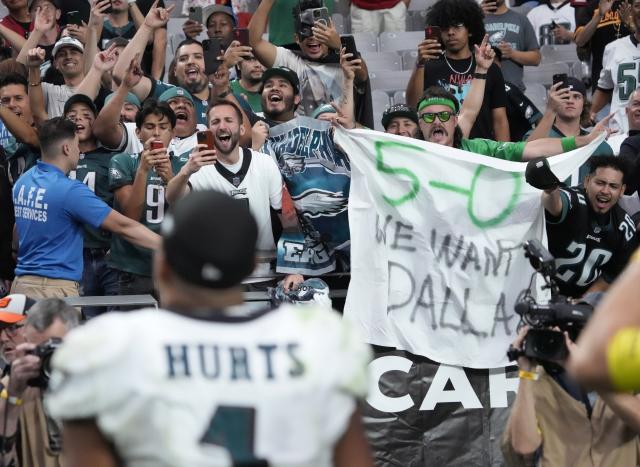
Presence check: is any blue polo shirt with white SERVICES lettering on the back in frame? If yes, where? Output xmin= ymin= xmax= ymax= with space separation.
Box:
xmin=13 ymin=161 xmax=111 ymax=281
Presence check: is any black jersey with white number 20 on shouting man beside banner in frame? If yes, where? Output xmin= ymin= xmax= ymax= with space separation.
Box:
xmin=546 ymin=188 xmax=637 ymax=298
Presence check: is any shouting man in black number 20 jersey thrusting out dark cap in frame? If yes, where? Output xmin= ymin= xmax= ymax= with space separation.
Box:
xmin=526 ymin=156 xmax=637 ymax=298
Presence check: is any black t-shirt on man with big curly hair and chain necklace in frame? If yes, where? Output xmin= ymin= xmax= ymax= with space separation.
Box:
xmin=424 ymin=57 xmax=507 ymax=139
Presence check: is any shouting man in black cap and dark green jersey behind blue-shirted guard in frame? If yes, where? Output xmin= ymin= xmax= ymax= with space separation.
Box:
xmin=64 ymin=94 xmax=118 ymax=318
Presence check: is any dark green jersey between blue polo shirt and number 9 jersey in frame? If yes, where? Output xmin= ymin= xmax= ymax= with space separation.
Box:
xmin=69 ymin=148 xmax=114 ymax=252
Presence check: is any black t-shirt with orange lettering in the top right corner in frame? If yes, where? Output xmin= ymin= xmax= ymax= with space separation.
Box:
xmin=575 ymin=0 xmax=630 ymax=92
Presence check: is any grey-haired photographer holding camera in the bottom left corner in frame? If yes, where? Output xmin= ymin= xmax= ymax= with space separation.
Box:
xmin=0 ymin=298 xmax=78 ymax=467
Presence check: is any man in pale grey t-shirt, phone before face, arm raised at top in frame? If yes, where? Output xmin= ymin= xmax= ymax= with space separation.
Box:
xmin=249 ymin=0 xmax=368 ymax=119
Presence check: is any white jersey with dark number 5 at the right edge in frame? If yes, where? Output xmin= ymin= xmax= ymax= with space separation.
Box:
xmin=598 ymin=34 xmax=640 ymax=133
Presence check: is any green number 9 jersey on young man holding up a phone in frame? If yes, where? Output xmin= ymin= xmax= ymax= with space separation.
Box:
xmin=109 ymin=153 xmax=189 ymax=277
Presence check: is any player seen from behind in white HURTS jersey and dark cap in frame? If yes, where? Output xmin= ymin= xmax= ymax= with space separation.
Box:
xmin=46 ymin=190 xmax=373 ymax=467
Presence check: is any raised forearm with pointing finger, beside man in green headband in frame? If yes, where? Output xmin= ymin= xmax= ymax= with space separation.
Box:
xmin=458 ymin=34 xmax=495 ymax=138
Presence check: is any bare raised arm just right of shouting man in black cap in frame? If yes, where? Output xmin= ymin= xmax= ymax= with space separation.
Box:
xmin=93 ymin=55 xmax=143 ymax=149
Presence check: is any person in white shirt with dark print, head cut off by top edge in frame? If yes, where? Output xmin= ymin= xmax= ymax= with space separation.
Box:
xmin=527 ymin=0 xmax=576 ymax=46
